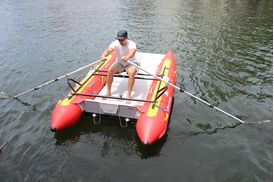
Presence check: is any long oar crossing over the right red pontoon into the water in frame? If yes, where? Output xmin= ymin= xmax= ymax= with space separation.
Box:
xmin=127 ymin=60 xmax=245 ymax=123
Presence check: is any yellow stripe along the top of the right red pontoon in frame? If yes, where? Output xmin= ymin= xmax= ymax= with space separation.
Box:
xmin=147 ymin=59 xmax=171 ymax=117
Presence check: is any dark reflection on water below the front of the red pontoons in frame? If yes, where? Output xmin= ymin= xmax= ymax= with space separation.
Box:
xmin=54 ymin=114 xmax=167 ymax=159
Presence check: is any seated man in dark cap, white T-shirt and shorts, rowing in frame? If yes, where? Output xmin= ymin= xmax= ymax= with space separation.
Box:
xmin=100 ymin=30 xmax=137 ymax=99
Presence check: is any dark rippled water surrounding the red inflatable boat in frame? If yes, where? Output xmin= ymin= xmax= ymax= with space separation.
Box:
xmin=0 ymin=0 xmax=273 ymax=182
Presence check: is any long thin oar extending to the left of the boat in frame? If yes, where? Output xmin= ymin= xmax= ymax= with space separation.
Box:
xmin=11 ymin=59 xmax=106 ymax=99
